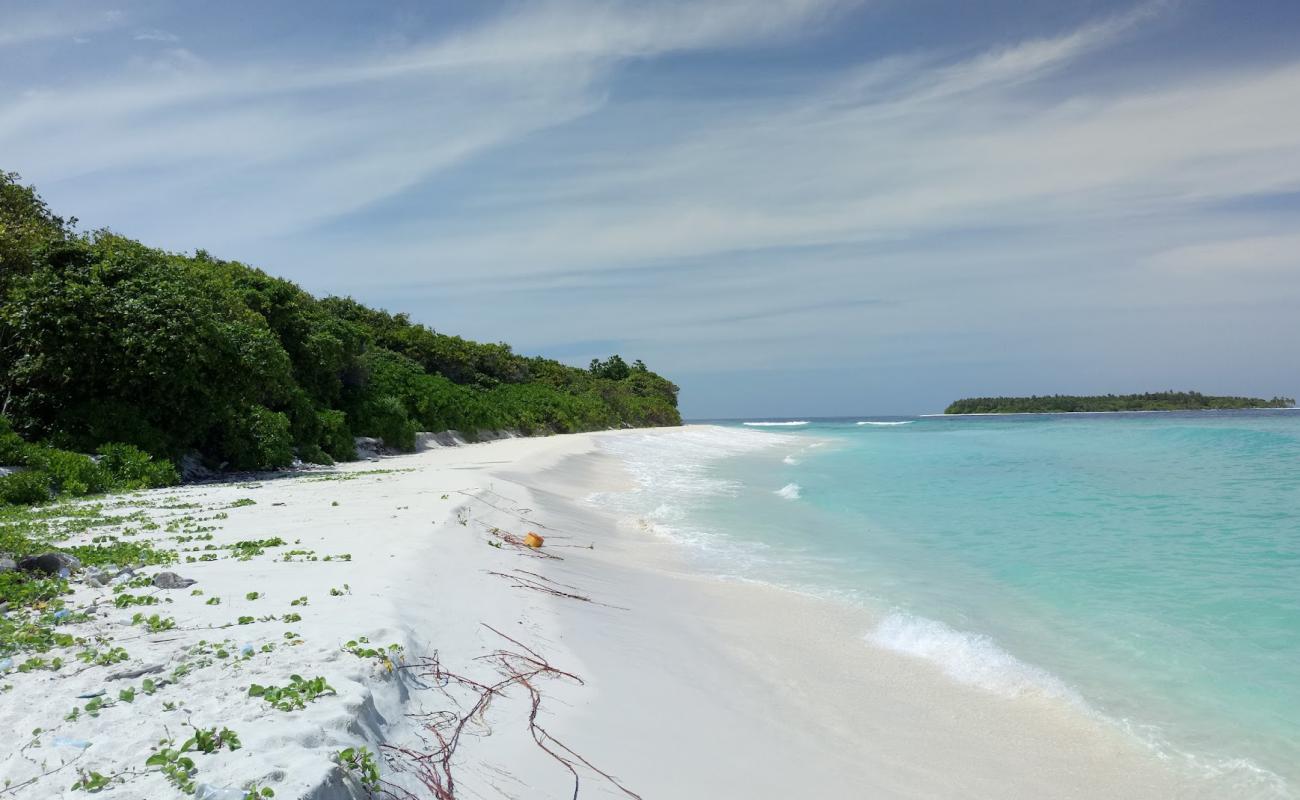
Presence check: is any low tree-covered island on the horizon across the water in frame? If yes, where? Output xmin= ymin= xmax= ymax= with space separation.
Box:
xmin=944 ymin=392 xmax=1296 ymax=414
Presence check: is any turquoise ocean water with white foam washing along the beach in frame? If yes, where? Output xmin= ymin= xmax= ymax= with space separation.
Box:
xmin=593 ymin=411 xmax=1300 ymax=799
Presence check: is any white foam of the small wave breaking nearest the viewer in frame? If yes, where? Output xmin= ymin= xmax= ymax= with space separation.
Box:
xmin=867 ymin=613 xmax=1083 ymax=705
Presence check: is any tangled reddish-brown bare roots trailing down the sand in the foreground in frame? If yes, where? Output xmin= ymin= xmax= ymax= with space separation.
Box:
xmin=381 ymin=623 xmax=641 ymax=800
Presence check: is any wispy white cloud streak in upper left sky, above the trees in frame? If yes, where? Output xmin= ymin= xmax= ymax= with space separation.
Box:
xmin=0 ymin=0 xmax=848 ymax=246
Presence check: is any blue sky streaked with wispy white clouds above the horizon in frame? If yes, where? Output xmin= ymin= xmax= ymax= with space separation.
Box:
xmin=0 ymin=0 xmax=1300 ymax=419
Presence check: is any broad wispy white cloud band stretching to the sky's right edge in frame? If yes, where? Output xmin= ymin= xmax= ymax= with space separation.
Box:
xmin=343 ymin=3 xmax=1300 ymax=282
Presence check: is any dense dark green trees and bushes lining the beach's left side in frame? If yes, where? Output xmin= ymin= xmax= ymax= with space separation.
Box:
xmin=0 ymin=172 xmax=681 ymax=507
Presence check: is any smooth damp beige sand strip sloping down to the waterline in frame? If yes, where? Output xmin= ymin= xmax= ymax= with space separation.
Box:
xmin=499 ymin=432 xmax=1213 ymax=799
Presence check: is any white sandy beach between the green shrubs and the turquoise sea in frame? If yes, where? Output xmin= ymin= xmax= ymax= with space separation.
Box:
xmin=0 ymin=431 xmax=1196 ymax=799
